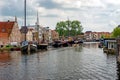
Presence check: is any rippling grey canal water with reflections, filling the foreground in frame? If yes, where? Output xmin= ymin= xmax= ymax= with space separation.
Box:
xmin=0 ymin=42 xmax=119 ymax=80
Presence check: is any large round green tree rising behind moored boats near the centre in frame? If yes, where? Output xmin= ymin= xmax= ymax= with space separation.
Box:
xmin=56 ymin=20 xmax=83 ymax=36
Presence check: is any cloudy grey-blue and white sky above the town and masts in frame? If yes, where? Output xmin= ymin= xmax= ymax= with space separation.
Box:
xmin=0 ymin=0 xmax=120 ymax=32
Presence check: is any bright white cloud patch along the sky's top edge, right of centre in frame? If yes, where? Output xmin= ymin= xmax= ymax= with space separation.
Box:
xmin=53 ymin=0 xmax=105 ymax=8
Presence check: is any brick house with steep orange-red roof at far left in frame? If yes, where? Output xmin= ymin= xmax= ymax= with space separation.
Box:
xmin=0 ymin=20 xmax=21 ymax=45
